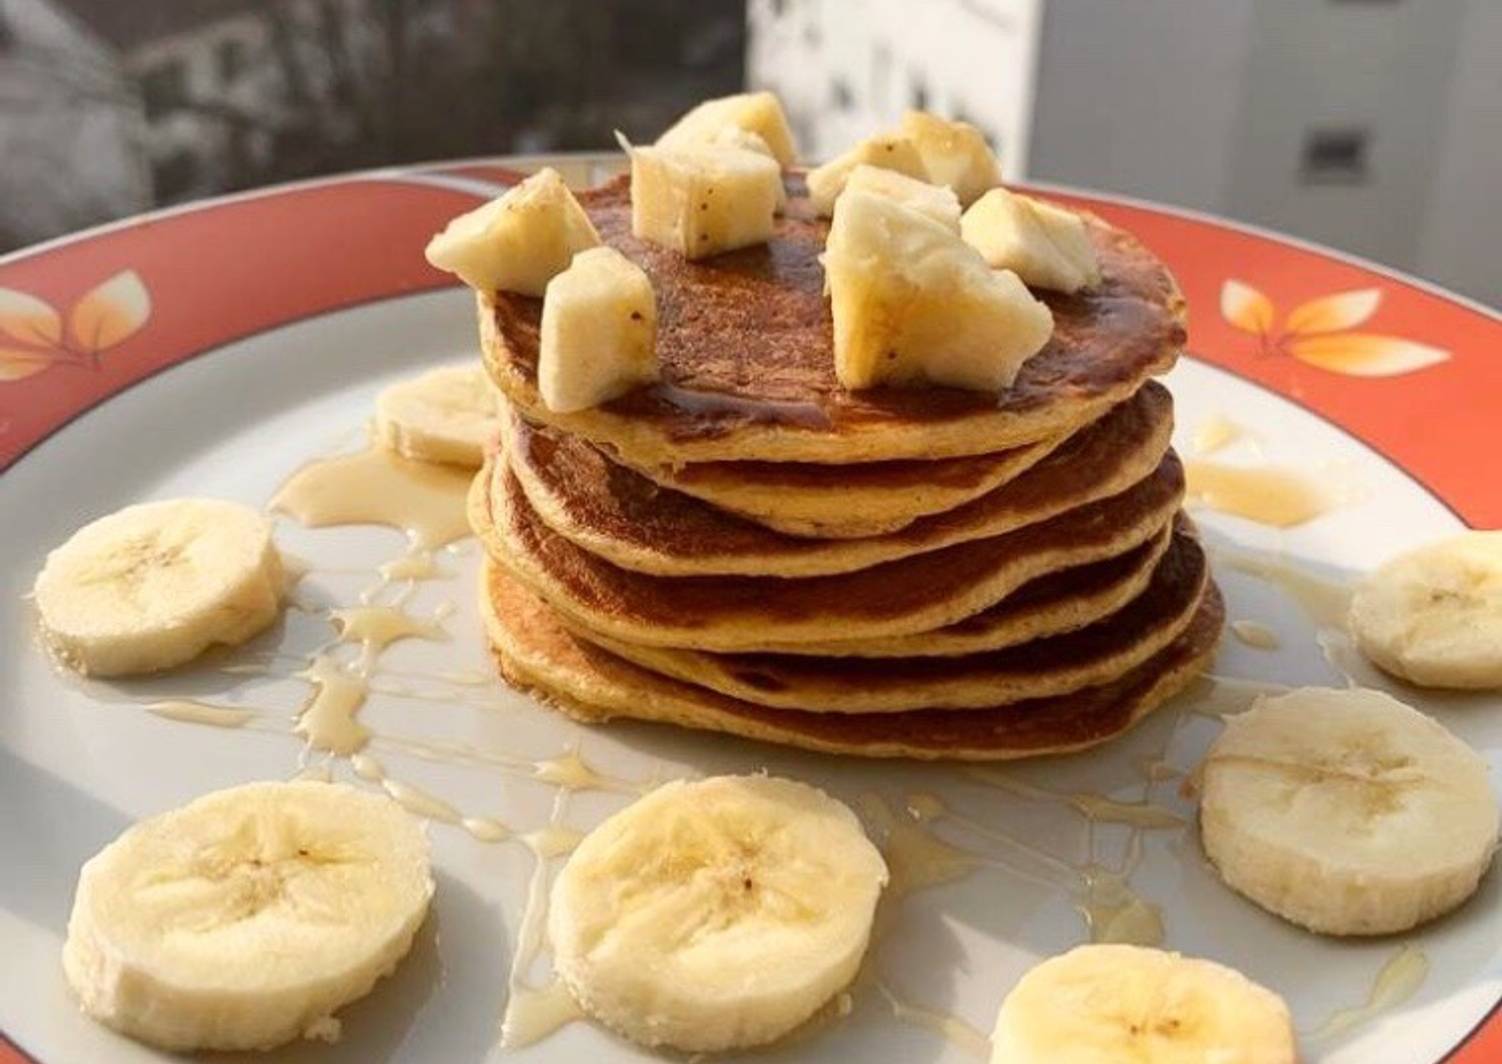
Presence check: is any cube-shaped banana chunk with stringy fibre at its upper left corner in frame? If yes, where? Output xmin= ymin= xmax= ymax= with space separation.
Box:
xmin=631 ymin=143 xmax=786 ymax=258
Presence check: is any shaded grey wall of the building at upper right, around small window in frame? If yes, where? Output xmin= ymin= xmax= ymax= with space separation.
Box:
xmin=1029 ymin=0 xmax=1502 ymax=304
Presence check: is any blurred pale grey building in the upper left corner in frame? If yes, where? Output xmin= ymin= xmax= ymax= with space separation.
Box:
xmin=0 ymin=0 xmax=152 ymax=248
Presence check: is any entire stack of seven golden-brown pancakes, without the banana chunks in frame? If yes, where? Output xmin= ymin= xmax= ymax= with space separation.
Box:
xmin=470 ymin=179 xmax=1223 ymax=759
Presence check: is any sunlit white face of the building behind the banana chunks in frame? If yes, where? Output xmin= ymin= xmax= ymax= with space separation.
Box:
xmin=746 ymin=0 xmax=1042 ymax=180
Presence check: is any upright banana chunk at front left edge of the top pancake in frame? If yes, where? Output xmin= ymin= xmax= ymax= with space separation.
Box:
xmin=538 ymin=248 xmax=658 ymax=412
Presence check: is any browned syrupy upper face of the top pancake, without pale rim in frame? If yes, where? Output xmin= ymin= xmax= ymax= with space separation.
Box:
xmin=488 ymin=177 xmax=1185 ymax=449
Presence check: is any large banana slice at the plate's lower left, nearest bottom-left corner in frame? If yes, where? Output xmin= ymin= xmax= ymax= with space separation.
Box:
xmin=63 ymin=781 xmax=433 ymax=1049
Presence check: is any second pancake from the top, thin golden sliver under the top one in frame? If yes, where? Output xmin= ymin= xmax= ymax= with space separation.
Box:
xmin=610 ymin=423 xmax=1075 ymax=540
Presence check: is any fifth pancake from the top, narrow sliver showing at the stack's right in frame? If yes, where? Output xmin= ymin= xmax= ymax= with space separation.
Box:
xmin=766 ymin=514 xmax=1185 ymax=658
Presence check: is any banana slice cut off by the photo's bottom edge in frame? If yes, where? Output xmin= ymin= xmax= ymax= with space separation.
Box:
xmin=991 ymin=944 xmax=1298 ymax=1064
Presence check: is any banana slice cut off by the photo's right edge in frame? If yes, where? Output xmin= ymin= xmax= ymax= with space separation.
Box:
xmin=1350 ymin=532 xmax=1502 ymax=688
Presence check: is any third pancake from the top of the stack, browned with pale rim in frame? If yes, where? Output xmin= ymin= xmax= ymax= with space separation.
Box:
xmin=505 ymin=383 xmax=1173 ymax=577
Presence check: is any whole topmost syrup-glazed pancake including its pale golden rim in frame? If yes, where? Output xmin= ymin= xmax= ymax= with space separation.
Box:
xmin=478 ymin=176 xmax=1185 ymax=467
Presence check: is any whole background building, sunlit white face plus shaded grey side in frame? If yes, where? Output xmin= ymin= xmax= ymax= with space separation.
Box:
xmin=746 ymin=0 xmax=1502 ymax=305
